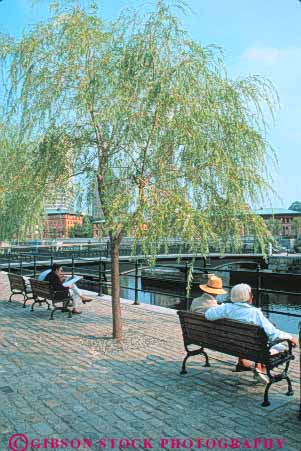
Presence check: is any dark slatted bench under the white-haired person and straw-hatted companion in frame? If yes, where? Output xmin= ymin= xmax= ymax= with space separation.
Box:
xmin=178 ymin=311 xmax=294 ymax=407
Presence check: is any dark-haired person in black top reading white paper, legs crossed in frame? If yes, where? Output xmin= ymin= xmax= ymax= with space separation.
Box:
xmin=44 ymin=263 xmax=92 ymax=314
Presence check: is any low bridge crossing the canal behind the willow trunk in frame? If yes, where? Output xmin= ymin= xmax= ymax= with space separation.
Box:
xmin=0 ymin=238 xmax=266 ymax=268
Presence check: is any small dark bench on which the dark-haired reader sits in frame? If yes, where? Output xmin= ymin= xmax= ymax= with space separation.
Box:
xmin=30 ymin=279 xmax=72 ymax=319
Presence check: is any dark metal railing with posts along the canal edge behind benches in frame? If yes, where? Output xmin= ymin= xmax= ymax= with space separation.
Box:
xmin=2 ymin=254 xmax=301 ymax=318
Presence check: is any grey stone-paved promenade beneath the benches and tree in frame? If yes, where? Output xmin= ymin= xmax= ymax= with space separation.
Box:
xmin=0 ymin=273 xmax=301 ymax=451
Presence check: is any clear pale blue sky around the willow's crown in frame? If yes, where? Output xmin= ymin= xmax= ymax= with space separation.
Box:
xmin=0 ymin=0 xmax=301 ymax=207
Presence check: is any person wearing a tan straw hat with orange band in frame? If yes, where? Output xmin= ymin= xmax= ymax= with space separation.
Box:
xmin=190 ymin=274 xmax=227 ymax=313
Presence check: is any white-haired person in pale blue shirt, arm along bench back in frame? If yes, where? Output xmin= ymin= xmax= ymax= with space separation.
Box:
xmin=205 ymin=283 xmax=297 ymax=383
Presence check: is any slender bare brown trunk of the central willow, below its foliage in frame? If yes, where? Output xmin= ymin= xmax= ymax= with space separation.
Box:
xmin=110 ymin=235 xmax=122 ymax=341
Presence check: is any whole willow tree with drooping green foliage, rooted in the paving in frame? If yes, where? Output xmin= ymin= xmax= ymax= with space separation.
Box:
xmin=3 ymin=0 xmax=277 ymax=339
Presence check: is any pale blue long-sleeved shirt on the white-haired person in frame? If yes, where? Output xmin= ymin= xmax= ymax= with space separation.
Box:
xmin=205 ymin=302 xmax=292 ymax=343
